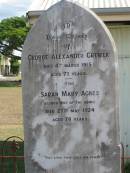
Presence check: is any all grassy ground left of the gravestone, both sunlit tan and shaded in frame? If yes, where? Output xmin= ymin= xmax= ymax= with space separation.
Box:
xmin=0 ymin=86 xmax=25 ymax=173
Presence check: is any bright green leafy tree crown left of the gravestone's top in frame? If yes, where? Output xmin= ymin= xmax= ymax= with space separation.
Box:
xmin=0 ymin=17 xmax=30 ymax=58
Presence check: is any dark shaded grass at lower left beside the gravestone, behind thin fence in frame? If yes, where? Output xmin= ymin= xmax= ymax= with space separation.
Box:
xmin=0 ymin=140 xmax=25 ymax=173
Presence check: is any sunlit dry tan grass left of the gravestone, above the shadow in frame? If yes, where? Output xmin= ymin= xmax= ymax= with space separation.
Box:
xmin=0 ymin=87 xmax=23 ymax=140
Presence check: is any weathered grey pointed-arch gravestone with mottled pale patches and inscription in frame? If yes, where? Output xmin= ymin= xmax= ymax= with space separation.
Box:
xmin=22 ymin=1 xmax=120 ymax=173
